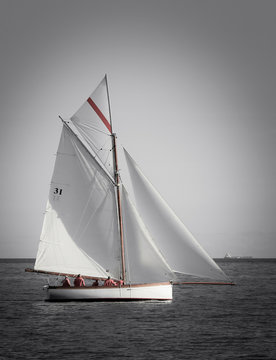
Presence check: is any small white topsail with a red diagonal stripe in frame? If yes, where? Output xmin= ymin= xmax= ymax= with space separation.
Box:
xmin=71 ymin=77 xmax=114 ymax=177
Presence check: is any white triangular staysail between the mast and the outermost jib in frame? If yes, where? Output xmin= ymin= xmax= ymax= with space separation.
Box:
xmin=122 ymin=187 xmax=174 ymax=283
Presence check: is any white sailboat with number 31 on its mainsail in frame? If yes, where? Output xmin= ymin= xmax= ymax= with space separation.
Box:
xmin=26 ymin=76 xmax=229 ymax=301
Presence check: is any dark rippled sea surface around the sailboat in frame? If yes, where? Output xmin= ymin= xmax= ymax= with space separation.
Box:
xmin=0 ymin=259 xmax=276 ymax=360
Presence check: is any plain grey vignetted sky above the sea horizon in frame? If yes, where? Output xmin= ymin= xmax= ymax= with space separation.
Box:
xmin=0 ymin=0 xmax=276 ymax=257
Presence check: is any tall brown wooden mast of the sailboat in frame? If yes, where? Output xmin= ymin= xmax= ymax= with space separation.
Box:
xmin=105 ymin=74 xmax=126 ymax=283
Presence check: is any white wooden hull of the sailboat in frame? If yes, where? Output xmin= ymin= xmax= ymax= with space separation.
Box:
xmin=47 ymin=283 xmax=172 ymax=301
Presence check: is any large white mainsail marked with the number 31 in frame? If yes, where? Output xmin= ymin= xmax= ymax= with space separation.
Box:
xmin=35 ymin=125 xmax=121 ymax=278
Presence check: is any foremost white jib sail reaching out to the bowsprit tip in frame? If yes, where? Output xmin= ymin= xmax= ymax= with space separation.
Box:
xmin=125 ymin=150 xmax=228 ymax=280
